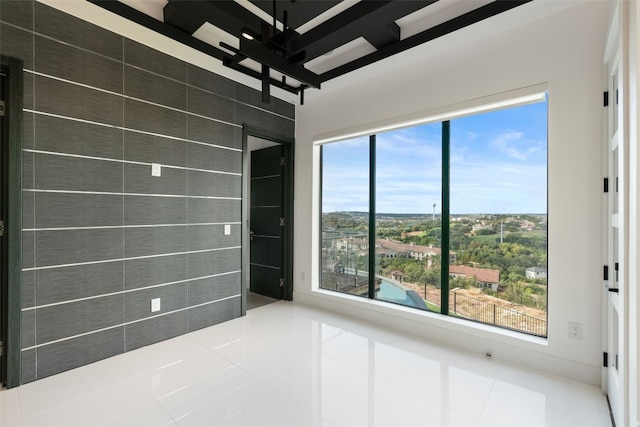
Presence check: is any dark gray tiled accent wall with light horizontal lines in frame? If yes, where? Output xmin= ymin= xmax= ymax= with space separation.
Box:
xmin=0 ymin=0 xmax=295 ymax=383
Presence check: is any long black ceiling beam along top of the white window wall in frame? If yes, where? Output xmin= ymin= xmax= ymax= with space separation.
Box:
xmin=320 ymin=0 xmax=532 ymax=83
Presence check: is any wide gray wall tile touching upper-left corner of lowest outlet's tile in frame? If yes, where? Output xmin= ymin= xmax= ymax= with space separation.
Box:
xmin=36 ymin=261 xmax=124 ymax=306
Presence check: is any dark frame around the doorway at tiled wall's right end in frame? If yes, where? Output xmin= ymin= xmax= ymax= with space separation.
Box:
xmin=241 ymin=124 xmax=294 ymax=316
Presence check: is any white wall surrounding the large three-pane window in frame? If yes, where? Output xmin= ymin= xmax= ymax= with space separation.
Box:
xmin=294 ymin=1 xmax=612 ymax=385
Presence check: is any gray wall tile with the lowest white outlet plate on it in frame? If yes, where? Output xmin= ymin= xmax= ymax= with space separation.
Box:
xmin=125 ymin=283 xmax=187 ymax=322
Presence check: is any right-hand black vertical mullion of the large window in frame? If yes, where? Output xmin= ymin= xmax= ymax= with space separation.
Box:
xmin=440 ymin=120 xmax=451 ymax=315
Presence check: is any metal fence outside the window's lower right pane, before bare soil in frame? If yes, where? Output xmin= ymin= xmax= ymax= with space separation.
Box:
xmin=449 ymin=291 xmax=547 ymax=337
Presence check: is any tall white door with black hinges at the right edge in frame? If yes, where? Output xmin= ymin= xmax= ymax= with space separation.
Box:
xmin=604 ymin=2 xmax=629 ymax=426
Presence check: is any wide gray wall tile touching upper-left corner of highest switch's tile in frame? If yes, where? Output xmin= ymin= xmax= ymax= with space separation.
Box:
xmin=35 ymin=114 xmax=123 ymax=159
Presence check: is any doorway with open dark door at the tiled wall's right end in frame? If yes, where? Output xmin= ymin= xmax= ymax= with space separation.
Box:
xmin=243 ymin=131 xmax=293 ymax=314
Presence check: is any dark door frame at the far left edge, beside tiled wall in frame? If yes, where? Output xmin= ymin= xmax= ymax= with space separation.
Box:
xmin=0 ymin=56 xmax=24 ymax=388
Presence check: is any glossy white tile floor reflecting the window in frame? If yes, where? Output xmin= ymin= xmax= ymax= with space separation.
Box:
xmin=0 ymin=302 xmax=611 ymax=427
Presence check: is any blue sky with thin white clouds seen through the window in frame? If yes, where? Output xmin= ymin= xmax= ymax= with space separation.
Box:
xmin=323 ymin=98 xmax=547 ymax=214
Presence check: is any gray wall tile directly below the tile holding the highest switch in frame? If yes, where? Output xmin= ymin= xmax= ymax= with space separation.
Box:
xmin=124 ymin=196 xmax=186 ymax=225
